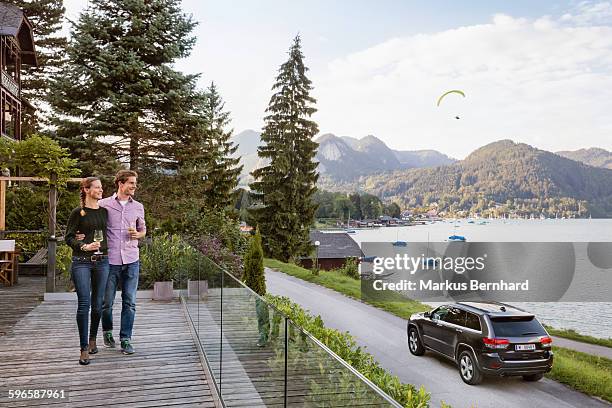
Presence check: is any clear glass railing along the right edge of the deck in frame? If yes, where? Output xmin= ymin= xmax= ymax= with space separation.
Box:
xmin=177 ymin=257 xmax=401 ymax=407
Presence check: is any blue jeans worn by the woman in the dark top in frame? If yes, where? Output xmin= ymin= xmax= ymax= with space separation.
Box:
xmin=72 ymin=257 xmax=109 ymax=350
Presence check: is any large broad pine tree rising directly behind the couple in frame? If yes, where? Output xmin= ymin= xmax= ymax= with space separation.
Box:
xmin=51 ymin=0 xmax=197 ymax=170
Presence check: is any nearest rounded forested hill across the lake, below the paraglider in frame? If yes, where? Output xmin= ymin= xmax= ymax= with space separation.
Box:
xmin=362 ymin=140 xmax=612 ymax=217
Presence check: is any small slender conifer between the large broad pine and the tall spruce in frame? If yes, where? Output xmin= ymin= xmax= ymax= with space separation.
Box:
xmin=204 ymin=83 xmax=243 ymax=209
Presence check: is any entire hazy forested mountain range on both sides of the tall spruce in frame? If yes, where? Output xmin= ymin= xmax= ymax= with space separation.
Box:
xmin=234 ymin=130 xmax=612 ymax=217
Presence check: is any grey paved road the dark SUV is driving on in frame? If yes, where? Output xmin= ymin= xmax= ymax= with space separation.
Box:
xmin=266 ymin=268 xmax=612 ymax=408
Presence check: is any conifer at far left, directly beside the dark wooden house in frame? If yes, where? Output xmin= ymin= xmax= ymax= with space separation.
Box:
xmin=6 ymin=0 xmax=67 ymax=136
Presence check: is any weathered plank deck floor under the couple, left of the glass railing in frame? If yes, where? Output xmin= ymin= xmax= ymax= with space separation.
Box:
xmin=0 ymin=294 xmax=215 ymax=408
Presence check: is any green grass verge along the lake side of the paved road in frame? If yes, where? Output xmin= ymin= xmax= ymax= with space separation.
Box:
xmin=264 ymin=258 xmax=612 ymax=402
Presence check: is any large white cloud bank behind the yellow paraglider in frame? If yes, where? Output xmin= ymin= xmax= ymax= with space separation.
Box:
xmin=313 ymin=7 xmax=612 ymax=157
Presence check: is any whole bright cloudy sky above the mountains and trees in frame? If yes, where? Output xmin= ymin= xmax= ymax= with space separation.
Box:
xmin=64 ymin=0 xmax=612 ymax=159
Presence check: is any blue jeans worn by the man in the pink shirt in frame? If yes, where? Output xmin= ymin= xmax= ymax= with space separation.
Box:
xmin=102 ymin=261 xmax=140 ymax=340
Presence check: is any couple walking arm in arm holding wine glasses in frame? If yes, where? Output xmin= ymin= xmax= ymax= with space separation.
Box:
xmin=66 ymin=170 xmax=146 ymax=365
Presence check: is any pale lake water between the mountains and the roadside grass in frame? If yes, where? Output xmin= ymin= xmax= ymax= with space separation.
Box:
xmin=340 ymin=219 xmax=612 ymax=338
